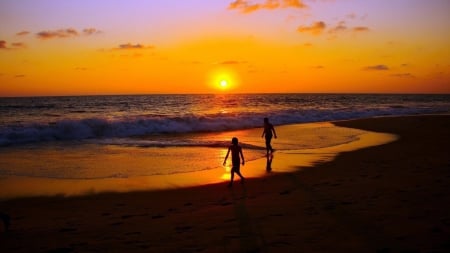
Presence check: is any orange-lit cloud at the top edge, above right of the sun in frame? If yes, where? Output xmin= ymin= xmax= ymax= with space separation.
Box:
xmin=228 ymin=0 xmax=307 ymax=13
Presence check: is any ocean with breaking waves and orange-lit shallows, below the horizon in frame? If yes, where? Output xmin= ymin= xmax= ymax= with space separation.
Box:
xmin=0 ymin=94 xmax=450 ymax=198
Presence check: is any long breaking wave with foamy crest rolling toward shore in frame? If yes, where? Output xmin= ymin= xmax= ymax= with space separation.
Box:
xmin=0 ymin=107 xmax=448 ymax=146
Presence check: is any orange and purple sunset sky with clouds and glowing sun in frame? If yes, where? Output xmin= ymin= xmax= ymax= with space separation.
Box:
xmin=0 ymin=0 xmax=450 ymax=96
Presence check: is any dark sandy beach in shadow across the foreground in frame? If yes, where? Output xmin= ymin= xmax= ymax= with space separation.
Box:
xmin=0 ymin=115 xmax=450 ymax=252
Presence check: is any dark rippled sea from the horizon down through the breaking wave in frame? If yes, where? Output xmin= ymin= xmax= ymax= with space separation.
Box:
xmin=0 ymin=94 xmax=450 ymax=147
